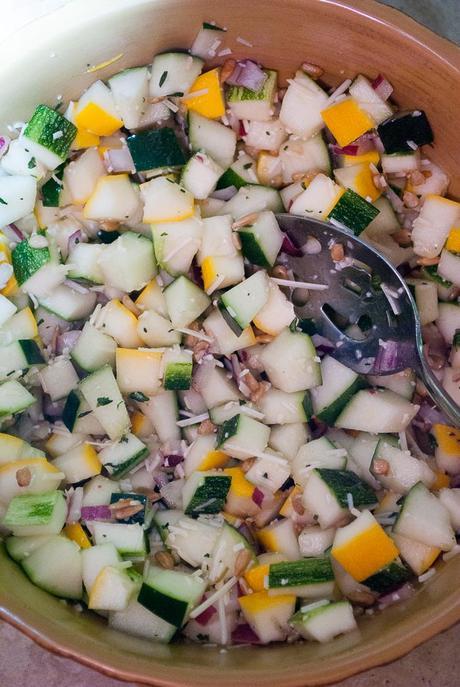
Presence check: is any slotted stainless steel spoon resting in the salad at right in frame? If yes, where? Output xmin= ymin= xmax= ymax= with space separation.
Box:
xmin=277 ymin=214 xmax=460 ymax=425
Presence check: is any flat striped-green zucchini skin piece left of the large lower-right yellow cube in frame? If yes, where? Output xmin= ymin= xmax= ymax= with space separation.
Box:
xmin=268 ymin=558 xmax=334 ymax=599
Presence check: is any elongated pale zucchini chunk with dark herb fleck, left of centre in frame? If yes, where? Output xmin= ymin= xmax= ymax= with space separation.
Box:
xmin=80 ymin=365 xmax=130 ymax=440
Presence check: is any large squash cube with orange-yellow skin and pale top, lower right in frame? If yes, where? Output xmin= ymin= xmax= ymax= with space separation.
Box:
xmin=331 ymin=511 xmax=399 ymax=582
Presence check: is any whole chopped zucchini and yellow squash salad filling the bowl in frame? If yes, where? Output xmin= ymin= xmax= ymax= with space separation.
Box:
xmin=0 ymin=18 xmax=460 ymax=645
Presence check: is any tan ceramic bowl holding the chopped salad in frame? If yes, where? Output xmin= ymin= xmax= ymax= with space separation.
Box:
xmin=0 ymin=0 xmax=460 ymax=687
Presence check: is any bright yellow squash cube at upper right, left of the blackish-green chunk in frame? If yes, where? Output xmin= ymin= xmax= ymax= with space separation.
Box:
xmin=321 ymin=98 xmax=375 ymax=146
